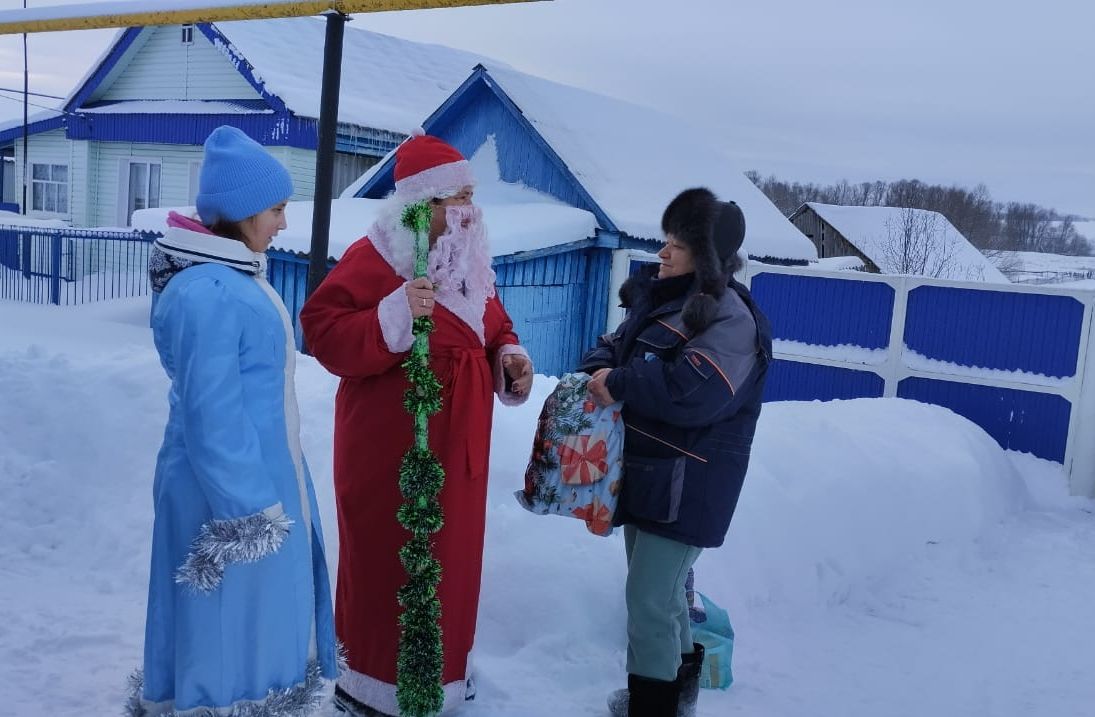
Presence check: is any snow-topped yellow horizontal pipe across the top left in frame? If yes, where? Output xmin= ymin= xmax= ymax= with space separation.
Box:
xmin=0 ymin=0 xmax=542 ymax=35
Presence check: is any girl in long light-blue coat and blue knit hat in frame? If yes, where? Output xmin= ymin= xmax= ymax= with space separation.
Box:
xmin=128 ymin=127 xmax=337 ymax=717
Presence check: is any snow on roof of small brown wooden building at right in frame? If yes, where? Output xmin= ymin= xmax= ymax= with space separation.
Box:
xmin=806 ymin=201 xmax=1007 ymax=282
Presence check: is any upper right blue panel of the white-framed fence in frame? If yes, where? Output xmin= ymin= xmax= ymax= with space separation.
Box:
xmin=904 ymin=286 xmax=1084 ymax=377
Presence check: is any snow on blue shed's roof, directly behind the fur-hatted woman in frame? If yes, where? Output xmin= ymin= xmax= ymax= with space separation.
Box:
xmin=475 ymin=63 xmax=817 ymax=261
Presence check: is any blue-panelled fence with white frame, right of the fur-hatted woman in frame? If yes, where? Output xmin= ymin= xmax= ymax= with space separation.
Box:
xmin=747 ymin=262 xmax=1095 ymax=496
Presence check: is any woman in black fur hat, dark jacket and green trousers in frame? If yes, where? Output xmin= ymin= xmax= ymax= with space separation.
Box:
xmin=580 ymin=188 xmax=772 ymax=717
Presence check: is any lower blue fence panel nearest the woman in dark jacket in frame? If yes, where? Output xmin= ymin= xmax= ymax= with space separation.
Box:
xmin=764 ymin=359 xmax=885 ymax=402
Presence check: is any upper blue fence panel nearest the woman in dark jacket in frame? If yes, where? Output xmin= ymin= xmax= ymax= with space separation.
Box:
xmin=750 ymin=274 xmax=895 ymax=348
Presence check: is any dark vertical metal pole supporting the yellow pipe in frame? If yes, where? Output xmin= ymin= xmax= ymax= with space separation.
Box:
xmin=307 ymin=12 xmax=346 ymax=296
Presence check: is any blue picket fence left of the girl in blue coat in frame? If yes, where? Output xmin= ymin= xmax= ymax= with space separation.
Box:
xmin=0 ymin=225 xmax=157 ymax=304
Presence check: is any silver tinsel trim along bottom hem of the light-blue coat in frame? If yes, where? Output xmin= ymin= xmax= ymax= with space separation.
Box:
xmin=125 ymin=660 xmax=331 ymax=717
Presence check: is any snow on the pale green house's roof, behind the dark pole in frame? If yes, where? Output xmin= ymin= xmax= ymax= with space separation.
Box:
xmin=215 ymin=18 xmax=501 ymax=134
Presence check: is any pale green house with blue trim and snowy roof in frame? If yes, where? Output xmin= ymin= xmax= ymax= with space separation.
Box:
xmin=0 ymin=18 xmax=483 ymax=227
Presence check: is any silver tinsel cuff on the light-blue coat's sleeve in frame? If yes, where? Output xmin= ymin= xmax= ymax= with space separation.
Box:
xmin=175 ymin=512 xmax=292 ymax=593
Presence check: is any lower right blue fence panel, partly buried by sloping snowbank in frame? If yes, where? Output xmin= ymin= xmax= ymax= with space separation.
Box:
xmin=897 ymin=378 xmax=1072 ymax=463
